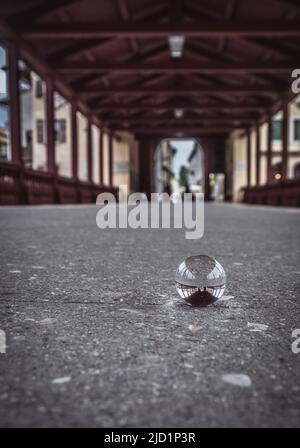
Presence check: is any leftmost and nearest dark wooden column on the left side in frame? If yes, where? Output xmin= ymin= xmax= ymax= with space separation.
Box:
xmin=7 ymin=42 xmax=22 ymax=165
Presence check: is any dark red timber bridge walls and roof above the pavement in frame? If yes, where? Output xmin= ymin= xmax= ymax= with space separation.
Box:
xmin=0 ymin=0 xmax=300 ymax=205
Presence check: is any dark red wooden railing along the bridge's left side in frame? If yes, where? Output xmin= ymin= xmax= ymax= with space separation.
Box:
xmin=0 ymin=162 xmax=118 ymax=205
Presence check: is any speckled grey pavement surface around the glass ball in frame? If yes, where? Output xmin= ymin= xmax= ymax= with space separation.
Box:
xmin=0 ymin=204 xmax=300 ymax=427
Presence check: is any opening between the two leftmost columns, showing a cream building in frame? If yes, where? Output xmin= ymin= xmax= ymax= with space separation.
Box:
xmin=18 ymin=60 xmax=47 ymax=170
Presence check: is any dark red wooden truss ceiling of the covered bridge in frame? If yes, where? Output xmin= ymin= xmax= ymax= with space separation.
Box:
xmin=1 ymin=0 xmax=300 ymax=204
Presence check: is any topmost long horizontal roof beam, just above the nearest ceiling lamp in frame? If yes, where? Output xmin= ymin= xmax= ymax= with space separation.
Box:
xmin=18 ymin=20 xmax=300 ymax=39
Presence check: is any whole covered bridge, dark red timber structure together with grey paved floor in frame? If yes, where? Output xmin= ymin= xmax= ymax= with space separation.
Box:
xmin=0 ymin=0 xmax=300 ymax=428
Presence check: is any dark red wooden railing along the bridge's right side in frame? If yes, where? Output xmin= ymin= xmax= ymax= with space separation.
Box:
xmin=243 ymin=179 xmax=300 ymax=207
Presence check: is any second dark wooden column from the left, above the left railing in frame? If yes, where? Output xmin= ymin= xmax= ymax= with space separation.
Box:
xmin=46 ymin=78 xmax=57 ymax=174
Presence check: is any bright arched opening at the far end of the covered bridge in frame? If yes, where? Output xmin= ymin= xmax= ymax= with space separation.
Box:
xmin=154 ymin=138 xmax=205 ymax=195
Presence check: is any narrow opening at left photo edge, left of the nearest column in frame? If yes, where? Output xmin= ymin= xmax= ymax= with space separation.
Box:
xmin=0 ymin=44 xmax=11 ymax=160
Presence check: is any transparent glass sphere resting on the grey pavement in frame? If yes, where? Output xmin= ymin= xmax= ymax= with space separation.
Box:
xmin=175 ymin=255 xmax=226 ymax=306
